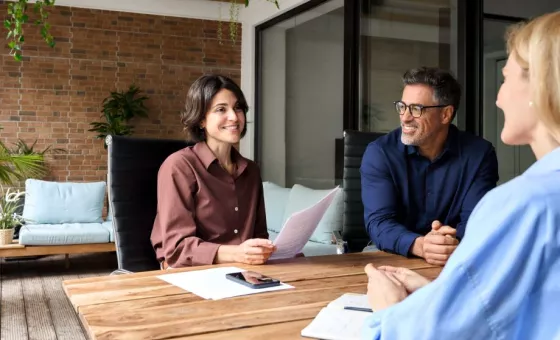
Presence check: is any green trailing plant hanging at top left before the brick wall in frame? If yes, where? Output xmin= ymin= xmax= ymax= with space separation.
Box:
xmin=4 ymin=0 xmax=56 ymax=61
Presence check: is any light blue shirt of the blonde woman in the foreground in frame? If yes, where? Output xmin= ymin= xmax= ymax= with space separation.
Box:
xmin=364 ymin=148 xmax=560 ymax=340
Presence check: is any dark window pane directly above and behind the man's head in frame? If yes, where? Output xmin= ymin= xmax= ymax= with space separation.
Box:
xmin=360 ymin=0 xmax=457 ymax=132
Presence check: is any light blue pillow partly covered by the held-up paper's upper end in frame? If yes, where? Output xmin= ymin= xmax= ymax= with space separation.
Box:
xmin=282 ymin=184 xmax=344 ymax=244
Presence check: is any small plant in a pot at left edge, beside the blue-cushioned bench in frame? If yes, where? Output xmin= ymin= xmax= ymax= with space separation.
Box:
xmin=0 ymin=189 xmax=25 ymax=245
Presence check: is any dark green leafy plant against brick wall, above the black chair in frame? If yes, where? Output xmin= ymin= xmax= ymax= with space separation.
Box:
xmin=88 ymin=85 xmax=149 ymax=148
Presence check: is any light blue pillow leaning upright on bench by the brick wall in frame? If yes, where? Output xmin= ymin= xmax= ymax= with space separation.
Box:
xmin=23 ymin=179 xmax=106 ymax=224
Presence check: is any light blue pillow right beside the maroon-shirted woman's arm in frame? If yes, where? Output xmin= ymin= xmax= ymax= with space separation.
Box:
xmin=263 ymin=182 xmax=291 ymax=233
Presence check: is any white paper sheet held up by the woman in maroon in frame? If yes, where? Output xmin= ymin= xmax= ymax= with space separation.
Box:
xmin=270 ymin=186 xmax=339 ymax=260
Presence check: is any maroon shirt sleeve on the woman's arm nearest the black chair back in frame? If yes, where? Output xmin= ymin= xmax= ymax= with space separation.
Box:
xmin=152 ymin=156 xmax=220 ymax=267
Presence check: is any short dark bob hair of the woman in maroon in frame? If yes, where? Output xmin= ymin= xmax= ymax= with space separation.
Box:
xmin=181 ymin=74 xmax=249 ymax=142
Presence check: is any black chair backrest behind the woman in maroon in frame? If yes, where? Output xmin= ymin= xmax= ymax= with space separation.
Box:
xmin=106 ymin=136 xmax=192 ymax=272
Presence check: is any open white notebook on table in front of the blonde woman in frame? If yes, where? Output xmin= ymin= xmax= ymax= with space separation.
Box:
xmin=301 ymin=294 xmax=371 ymax=340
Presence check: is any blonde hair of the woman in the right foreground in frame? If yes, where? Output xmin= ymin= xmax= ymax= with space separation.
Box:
xmin=506 ymin=12 xmax=560 ymax=140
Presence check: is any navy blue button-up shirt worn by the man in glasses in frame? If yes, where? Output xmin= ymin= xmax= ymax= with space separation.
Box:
xmin=360 ymin=125 xmax=498 ymax=256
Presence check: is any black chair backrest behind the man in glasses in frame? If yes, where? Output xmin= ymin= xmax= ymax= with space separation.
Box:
xmin=342 ymin=130 xmax=384 ymax=252
